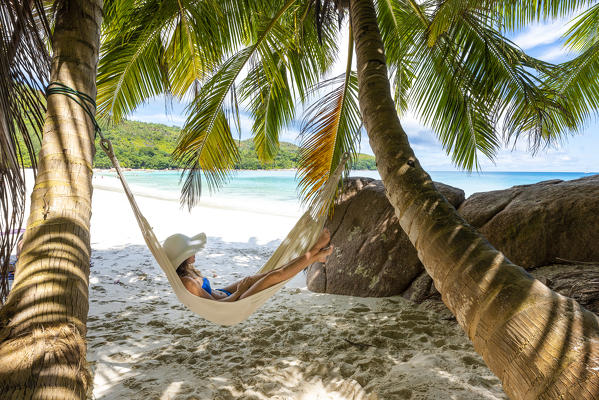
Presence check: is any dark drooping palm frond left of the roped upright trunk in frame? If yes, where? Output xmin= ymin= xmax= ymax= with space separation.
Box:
xmin=0 ymin=0 xmax=50 ymax=303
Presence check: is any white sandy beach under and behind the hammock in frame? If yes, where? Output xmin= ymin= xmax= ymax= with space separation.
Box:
xmin=88 ymin=178 xmax=506 ymax=400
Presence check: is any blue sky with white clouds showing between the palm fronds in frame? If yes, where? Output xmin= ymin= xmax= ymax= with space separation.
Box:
xmin=130 ymin=12 xmax=599 ymax=172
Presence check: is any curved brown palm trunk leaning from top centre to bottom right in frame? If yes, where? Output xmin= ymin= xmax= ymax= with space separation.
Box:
xmin=350 ymin=0 xmax=599 ymax=400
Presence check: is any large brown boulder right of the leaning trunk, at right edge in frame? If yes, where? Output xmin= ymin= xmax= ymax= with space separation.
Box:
xmin=458 ymin=175 xmax=599 ymax=268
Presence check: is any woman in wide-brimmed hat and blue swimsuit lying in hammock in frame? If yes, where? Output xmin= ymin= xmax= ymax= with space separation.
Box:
xmin=163 ymin=228 xmax=333 ymax=301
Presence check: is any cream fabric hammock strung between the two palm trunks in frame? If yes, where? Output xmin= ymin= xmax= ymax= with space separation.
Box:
xmin=101 ymin=138 xmax=349 ymax=326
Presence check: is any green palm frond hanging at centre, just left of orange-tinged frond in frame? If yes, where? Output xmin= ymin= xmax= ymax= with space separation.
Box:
xmin=241 ymin=0 xmax=337 ymax=162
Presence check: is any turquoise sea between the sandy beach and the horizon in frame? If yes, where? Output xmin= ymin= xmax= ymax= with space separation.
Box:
xmin=96 ymin=170 xmax=593 ymax=215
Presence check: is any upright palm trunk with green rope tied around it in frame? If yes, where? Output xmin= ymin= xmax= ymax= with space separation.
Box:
xmin=0 ymin=0 xmax=102 ymax=399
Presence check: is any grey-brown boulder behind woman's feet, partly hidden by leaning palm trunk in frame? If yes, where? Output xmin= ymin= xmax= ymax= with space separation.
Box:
xmin=307 ymin=178 xmax=464 ymax=297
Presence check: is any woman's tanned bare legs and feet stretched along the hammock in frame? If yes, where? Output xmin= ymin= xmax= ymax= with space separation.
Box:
xmin=239 ymin=229 xmax=333 ymax=299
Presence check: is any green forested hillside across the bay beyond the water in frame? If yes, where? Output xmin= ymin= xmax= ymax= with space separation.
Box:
xmin=17 ymin=121 xmax=376 ymax=170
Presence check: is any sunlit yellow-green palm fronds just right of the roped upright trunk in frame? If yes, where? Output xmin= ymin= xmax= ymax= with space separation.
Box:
xmin=97 ymin=0 xmax=231 ymax=122
